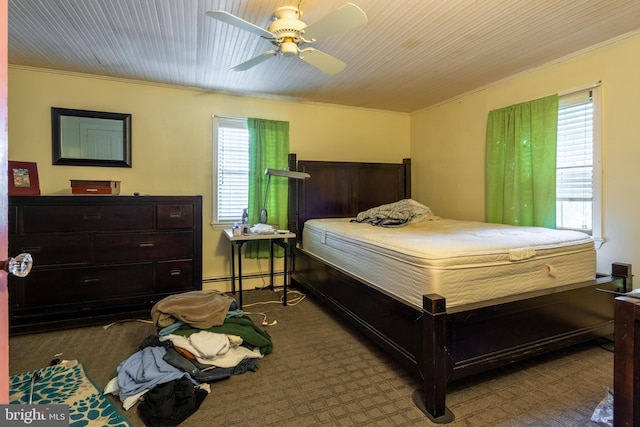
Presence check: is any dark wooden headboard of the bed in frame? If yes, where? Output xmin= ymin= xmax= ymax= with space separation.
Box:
xmin=289 ymin=154 xmax=411 ymax=236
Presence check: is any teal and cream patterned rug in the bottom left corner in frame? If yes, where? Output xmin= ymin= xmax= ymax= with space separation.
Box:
xmin=9 ymin=360 xmax=131 ymax=427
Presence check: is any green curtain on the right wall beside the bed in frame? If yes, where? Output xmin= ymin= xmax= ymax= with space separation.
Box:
xmin=486 ymin=95 xmax=558 ymax=228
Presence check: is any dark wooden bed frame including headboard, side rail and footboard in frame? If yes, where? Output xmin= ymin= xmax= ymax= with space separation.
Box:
xmin=289 ymin=154 xmax=630 ymax=423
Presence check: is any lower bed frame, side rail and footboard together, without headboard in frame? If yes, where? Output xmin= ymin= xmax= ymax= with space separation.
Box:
xmin=292 ymin=250 xmax=628 ymax=423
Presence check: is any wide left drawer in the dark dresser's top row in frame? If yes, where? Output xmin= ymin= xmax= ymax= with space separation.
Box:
xmin=19 ymin=204 xmax=154 ymax=233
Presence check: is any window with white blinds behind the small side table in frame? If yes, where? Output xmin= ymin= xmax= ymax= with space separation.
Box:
xmin=213 ymin=116 xmax=249 ymax=223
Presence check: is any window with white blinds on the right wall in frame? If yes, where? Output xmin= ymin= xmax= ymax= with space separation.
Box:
xmin=556 ymin=88 xmax=601 ymax=242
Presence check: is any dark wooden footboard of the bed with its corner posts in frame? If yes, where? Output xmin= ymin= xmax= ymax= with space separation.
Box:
xmin=414 ymin=270 xmax=627 ymax=423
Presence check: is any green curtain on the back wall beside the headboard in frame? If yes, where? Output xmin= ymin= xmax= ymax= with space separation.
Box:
xmin=245 ymin=118 xmax=289 ymax=258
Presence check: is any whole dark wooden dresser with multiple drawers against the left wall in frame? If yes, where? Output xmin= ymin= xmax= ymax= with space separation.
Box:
xmin=9 ymin=196 xmax=202 ymax=335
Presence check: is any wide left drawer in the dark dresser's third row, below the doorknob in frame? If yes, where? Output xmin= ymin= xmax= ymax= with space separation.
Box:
xmin=17 ymin=263 xmax=153 ymax=307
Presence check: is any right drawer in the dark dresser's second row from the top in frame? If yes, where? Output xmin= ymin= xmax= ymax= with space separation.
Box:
xmin=95 ymin=230 xmax=194 ymax=262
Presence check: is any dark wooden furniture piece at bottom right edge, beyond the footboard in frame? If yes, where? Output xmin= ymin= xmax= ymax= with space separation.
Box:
xmin=613 ymin=297 xmax=640 ymax=427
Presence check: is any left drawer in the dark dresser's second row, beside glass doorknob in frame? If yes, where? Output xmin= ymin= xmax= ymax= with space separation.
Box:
xmin=9 ymin=234 xmax=91 ymax=268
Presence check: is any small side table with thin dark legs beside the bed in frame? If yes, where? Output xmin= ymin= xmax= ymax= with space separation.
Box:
xmin=224 ymin=228 xmax=296 ymax=308
